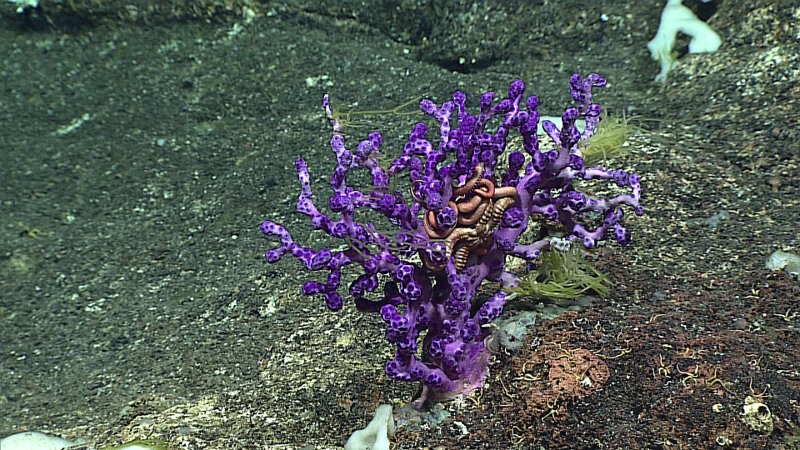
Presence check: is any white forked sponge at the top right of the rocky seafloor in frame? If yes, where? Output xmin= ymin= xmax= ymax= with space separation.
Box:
xmin=647 ymin=0 xmax=722 ymax=83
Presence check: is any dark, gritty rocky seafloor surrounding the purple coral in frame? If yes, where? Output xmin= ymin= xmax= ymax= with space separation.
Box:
xmin=0 ymin=0 xmax=800 ymax=449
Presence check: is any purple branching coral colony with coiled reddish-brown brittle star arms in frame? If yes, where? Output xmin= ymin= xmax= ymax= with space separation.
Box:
xmin=261 ymin=74 xmax=642 ymax=406
